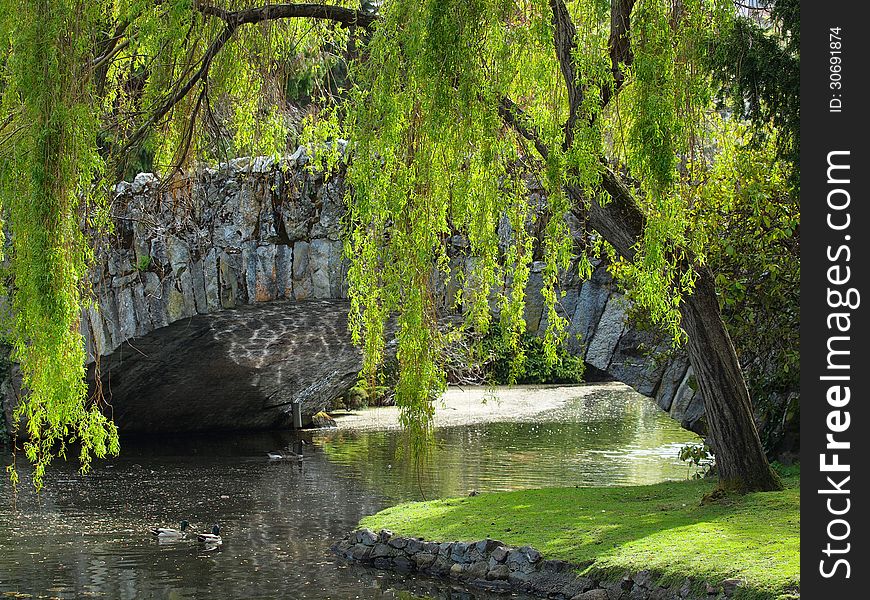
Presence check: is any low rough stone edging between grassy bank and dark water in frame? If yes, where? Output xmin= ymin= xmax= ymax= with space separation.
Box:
xmin=332 ymin=529 xmax=741 ymax=600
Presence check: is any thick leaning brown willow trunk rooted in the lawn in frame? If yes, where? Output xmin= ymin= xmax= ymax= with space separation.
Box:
xmin=567 ymin=168 xmax=782 ymax=492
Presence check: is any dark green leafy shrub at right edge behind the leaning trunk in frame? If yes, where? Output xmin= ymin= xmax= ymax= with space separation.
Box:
xmin=707 ymin=127 xmax=800 ymax=453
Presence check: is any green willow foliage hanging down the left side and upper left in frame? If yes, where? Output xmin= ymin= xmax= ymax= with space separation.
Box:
xmin=0 ymin=0 xmax=347 ymax=488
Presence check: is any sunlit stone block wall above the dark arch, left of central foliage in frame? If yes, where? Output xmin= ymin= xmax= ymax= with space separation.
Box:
xmin=82 ymin=151 xmax=346 ymax=360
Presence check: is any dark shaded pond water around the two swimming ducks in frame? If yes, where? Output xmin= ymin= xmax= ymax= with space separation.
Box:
xmin=0 ymin=436 xmax=524 ymax=599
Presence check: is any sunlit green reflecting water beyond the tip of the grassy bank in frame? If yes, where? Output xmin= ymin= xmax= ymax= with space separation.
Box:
xmin=315 ymin=390 xmax=696 ymax=499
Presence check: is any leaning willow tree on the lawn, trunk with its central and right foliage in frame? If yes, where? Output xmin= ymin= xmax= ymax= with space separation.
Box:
xmin=326 ymin=0 xmax=779 ymax=490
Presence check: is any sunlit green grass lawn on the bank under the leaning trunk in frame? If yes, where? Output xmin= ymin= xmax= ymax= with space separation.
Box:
xmin=360 ymin=471 xmax=800 ymax=599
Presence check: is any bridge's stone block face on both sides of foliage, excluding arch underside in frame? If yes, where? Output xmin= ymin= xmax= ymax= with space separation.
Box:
xmin=5 ymin=148 xmax=703 ymax=430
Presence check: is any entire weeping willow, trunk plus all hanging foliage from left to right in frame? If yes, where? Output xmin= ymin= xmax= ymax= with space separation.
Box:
xmin=3 ymin=0 xmax=792 ymax=491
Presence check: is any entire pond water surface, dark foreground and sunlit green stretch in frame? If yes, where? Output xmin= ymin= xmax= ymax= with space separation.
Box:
xmin=0 ymin=386 xmax=696 ymax=600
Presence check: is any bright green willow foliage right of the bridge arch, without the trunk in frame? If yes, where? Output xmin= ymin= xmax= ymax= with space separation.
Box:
xmin=314 ymin=0 xmax=744 ymax=464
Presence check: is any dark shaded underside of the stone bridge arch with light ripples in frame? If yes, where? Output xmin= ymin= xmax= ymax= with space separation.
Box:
xmin=91 ymin=300 xmax=362 ymax=433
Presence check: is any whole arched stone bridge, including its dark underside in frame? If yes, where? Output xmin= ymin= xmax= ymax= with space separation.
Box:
xmin=6 ymin=149 xmax=703 ymax=432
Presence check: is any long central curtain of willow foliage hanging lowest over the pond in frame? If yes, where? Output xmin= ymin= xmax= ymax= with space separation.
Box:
xmin=314 ymin=0 xmax=570 ymax=464
